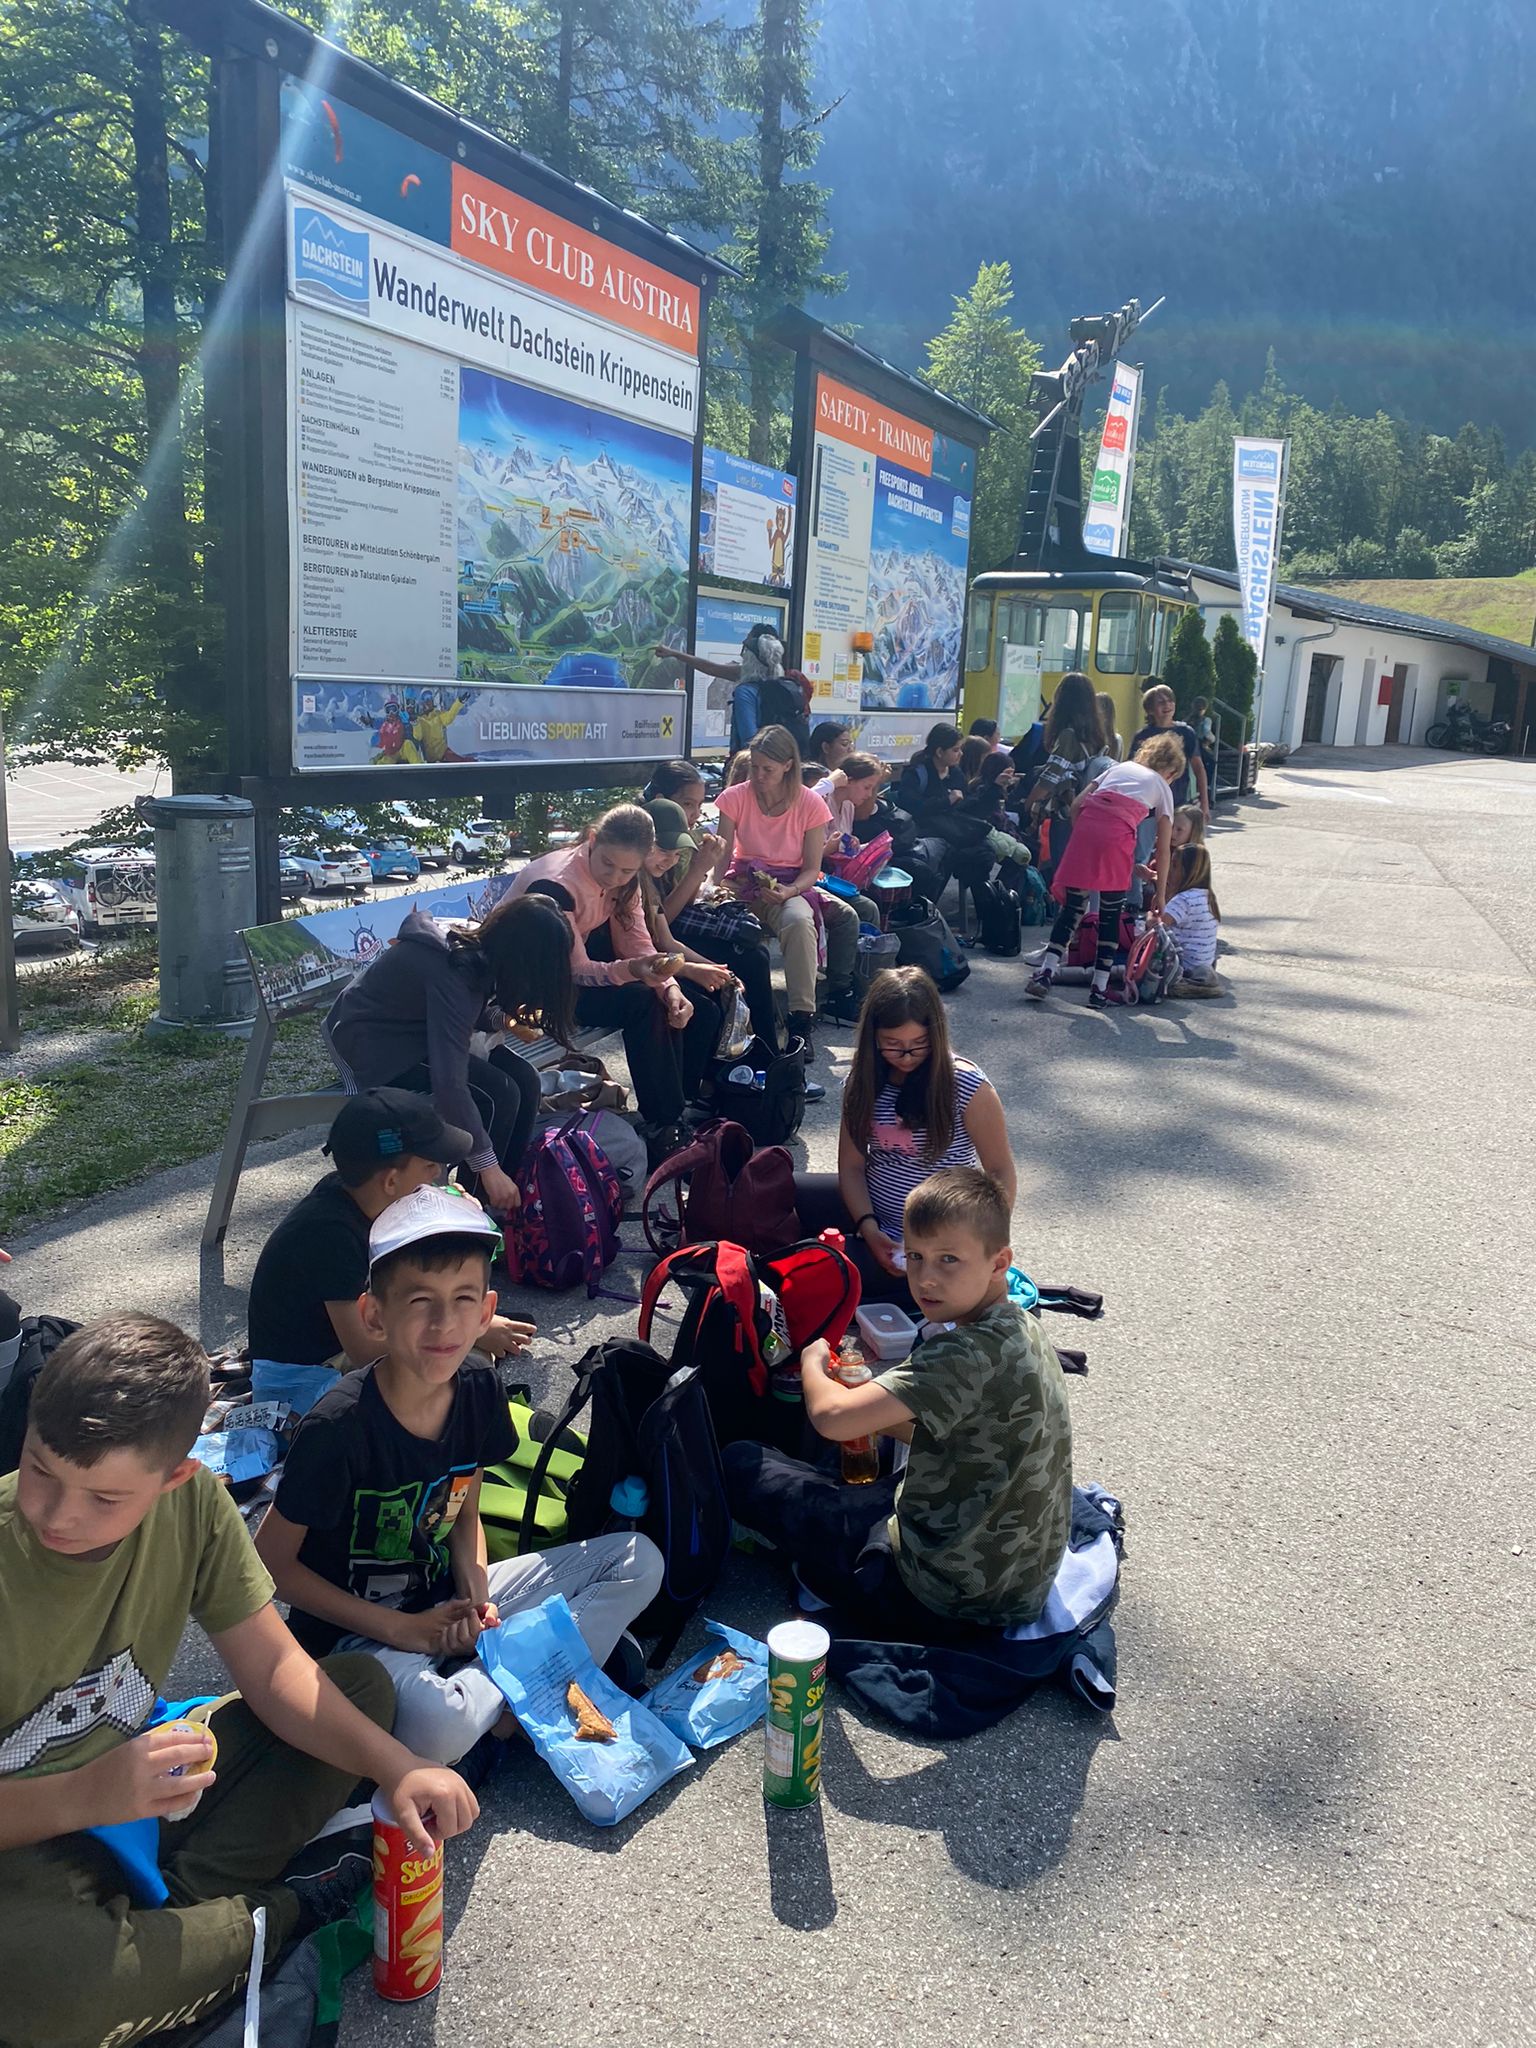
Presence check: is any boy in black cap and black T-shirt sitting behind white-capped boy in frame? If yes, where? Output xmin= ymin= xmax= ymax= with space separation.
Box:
xmin=248 ymin=1087 xmax=532 ymax=1372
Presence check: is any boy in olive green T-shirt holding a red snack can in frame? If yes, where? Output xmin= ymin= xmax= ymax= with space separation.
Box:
xmin=0 ymin=1315 xmax=477 ymax=2048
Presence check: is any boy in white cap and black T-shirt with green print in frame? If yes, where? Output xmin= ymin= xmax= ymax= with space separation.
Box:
xmin=256 ymin=1188 xmax=662 ymax=1763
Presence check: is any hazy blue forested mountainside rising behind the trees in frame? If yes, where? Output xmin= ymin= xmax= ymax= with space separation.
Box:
xmin=815 ymin=0 xmax=1536 ymax=444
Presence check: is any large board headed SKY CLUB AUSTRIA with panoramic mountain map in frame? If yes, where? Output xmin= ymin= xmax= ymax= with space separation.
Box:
xmin=283 ymin=80 xmax=700 ymax=772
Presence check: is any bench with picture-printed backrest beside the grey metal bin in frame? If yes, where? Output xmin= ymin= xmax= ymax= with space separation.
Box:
xmin=203 ymin=881 xmax=612 ymax=1249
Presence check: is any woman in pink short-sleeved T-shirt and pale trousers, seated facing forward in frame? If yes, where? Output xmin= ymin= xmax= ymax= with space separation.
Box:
xmin=712 ymin=725 xmax=858 ymax=1057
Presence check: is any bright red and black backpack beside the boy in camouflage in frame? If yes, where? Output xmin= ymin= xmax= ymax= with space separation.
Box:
xmin=637 ymin=1233 xmax=858 ymax=1452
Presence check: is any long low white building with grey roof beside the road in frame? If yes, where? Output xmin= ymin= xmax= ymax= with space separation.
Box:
xmin=1190 ymin=563 xmax=1536 ymax=754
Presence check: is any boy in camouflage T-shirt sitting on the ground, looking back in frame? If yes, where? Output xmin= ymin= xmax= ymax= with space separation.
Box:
xmin=725 ymin=1167 xmax=1071 ymax=1642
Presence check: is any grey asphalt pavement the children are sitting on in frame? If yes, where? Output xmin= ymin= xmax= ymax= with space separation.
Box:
xmin=6 ymin=750 xmax=1536 ymax=2048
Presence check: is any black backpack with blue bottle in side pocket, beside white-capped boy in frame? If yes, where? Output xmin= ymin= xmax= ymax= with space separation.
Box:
xmin=528 ymin=1337 xmax=731 ymax=1665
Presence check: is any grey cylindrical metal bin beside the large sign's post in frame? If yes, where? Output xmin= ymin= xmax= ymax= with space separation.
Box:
xmin=139 ymin=797 xmax=256 ymax=1036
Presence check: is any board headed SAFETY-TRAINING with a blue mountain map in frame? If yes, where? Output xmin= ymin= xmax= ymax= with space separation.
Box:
xmin=801 ymin=373 xmax=975 ymax=743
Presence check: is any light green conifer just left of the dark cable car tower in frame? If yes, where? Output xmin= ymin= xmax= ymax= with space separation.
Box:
xmin=922 ymin=262 xmax=1040 ymax=573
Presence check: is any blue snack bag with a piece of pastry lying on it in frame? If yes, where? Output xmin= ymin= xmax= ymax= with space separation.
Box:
xmin=475 ymin=1593 xmax=692 ymax=1827
